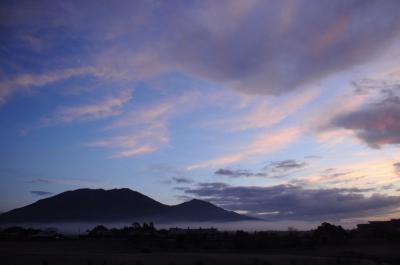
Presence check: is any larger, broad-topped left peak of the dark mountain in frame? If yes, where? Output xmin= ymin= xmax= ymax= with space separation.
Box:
xmin=0 ymin=189 xmax=168 ymax=223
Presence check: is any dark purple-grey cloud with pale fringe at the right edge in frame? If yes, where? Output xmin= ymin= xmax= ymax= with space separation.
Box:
xmin=315 ymin=68 xmax=400 ymax=149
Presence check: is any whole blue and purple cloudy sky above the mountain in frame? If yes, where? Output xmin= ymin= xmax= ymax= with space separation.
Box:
xmin=0 ymin=0 xmax=400 ymax=226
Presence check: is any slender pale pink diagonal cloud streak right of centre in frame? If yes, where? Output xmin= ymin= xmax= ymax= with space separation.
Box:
xmin=187 ymin=128 xmax=300 ymax=170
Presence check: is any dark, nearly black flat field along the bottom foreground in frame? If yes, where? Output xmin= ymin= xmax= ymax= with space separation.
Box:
xmin=0 ymin=239 xmax=400 ymax=265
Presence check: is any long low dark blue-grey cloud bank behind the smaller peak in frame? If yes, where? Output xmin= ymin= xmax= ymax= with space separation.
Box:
xmin=183 ymin=180 xmax=400 ymax=221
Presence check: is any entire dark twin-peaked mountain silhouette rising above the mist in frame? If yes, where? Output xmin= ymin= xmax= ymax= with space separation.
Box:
xmin=0 ymin=189 xmax=255 ymax=224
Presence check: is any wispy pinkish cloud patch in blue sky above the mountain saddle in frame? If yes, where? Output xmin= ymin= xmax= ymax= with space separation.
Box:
xmin=86 ymin=91 xmax=199 ymax=158
